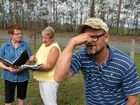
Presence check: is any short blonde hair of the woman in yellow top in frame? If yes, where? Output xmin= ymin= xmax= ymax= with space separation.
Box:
xmin=42 ymin=26 xmax=55 ymax=38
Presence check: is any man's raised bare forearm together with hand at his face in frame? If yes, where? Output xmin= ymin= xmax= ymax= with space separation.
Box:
xmin=55 ymin=33 xmax=92 ymax=82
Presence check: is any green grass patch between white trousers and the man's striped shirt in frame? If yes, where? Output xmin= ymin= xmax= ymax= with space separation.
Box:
xmin=58 ymin=73 xmax=84 ymax=105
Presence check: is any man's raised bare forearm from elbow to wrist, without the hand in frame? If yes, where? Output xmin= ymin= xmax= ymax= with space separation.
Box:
xmin=55 ymin=41 xmax=75 ymax=82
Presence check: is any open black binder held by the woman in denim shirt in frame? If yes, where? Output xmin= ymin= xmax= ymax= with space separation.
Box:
xmin=0 ymin=51 xmax=29 ymax=67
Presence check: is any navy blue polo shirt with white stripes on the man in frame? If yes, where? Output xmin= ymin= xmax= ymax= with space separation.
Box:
xmin=70 ymin=46 xmax=140 ymax=105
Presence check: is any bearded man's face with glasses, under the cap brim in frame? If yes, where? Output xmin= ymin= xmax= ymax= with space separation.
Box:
xmin=83 ymin=27 xmax=109 ymax=56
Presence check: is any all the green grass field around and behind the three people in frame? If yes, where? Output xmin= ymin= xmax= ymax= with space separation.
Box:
xmin=0 ymin=34 xmax=140 ymax=105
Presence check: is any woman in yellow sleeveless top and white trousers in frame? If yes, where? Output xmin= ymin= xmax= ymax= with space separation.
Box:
xmin=31 ymin=26 xmax=61 ymax=105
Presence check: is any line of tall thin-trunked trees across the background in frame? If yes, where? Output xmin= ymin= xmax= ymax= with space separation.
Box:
xmin=0 ymin=0 xmax=140 ymax=36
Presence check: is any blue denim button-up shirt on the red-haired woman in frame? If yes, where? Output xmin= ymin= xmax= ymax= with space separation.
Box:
xmin=0 ymin=40 xmax=31 ymax=82
